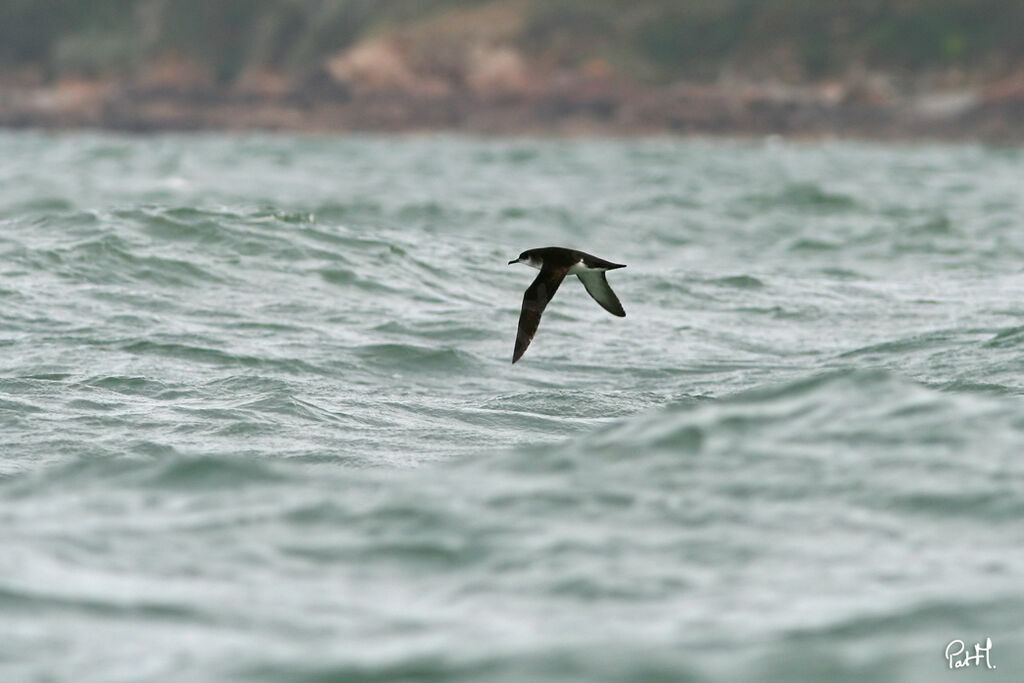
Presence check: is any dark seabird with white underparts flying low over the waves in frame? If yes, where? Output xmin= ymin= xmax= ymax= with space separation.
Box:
xmin=509 ymin=247 xmax=626 ymax=362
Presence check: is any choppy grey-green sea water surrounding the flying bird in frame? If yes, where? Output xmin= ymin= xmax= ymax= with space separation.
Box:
xmin=0 ymin=133 xmax=1024 ymax=682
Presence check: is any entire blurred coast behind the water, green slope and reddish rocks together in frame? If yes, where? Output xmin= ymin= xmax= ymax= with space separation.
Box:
xmin=0 ymin=0 xmax=1024 ymax=142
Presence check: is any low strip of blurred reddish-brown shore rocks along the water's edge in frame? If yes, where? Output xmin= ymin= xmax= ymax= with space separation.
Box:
xmin=0 ymin=79 xmax=1024 ymax=143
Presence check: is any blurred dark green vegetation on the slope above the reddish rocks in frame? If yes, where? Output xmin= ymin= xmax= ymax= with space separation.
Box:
xmin=0 ymin=0 xmax=1024 ymax=82
